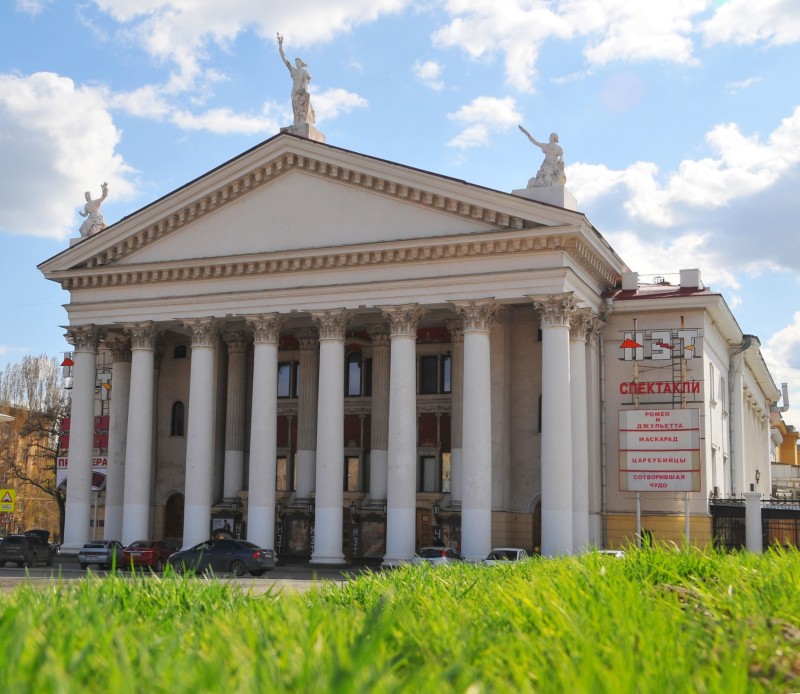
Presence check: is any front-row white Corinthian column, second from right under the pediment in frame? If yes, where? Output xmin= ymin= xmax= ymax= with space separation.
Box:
xmin=454 ymin=299 xmax=498 ymax=561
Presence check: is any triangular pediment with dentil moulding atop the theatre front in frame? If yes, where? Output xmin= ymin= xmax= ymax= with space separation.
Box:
xmin=41 ymin=135 xmax=580 ymax=273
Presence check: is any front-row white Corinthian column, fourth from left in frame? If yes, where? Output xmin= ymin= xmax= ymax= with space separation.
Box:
xmin=247 ymin=313 xmax=281 ymax=548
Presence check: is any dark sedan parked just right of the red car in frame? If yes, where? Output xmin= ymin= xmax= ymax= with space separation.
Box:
xmin=169 ymin=539 xmax=276 ymax=576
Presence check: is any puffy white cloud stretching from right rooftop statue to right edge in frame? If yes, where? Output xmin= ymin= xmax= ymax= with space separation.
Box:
xmin=567 ymin=107 xmax=800 ymax=228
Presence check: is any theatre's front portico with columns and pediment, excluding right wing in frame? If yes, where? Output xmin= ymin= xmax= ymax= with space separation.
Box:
xmin=42 ymin=134 xmax=625 ymax=565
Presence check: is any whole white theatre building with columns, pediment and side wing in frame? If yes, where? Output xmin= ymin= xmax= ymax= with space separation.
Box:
xmin=40 ymin=133 xmax=780 ymax=565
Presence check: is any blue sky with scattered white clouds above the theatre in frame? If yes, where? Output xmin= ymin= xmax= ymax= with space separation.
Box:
xmin=0 ymin=0 xmax=800 ymax=425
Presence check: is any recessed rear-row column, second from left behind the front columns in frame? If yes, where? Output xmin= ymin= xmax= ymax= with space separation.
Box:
xmin=295 ymin=329 xmax=319 ymax=499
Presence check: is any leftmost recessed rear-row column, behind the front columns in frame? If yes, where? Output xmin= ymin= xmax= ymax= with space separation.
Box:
xmin=222 ymin=331 xmax=247 ymax=499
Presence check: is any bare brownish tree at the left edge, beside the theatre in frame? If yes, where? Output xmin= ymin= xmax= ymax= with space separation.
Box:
xmin=0 ymin=354 xmax=70 ymax=538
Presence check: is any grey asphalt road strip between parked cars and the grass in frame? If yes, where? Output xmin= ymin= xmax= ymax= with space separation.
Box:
xmin=0 ymin=557 xmax=377 ymax=594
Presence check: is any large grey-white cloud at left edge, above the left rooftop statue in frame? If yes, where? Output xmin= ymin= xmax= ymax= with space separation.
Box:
xmin=0 ymin=72 xmax=133 ymax=239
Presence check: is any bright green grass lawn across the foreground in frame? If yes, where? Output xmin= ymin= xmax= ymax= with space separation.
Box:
xmin=0 ymin=548 xmax=800 ymax=694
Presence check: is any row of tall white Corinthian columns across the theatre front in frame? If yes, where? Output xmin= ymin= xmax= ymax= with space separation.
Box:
xmin=64 ymin=293 xmax=593 ymax=565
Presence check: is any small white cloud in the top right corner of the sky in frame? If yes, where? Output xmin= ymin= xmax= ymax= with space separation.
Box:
xmin=699 ymin=0 xmax=800 ymax=45
